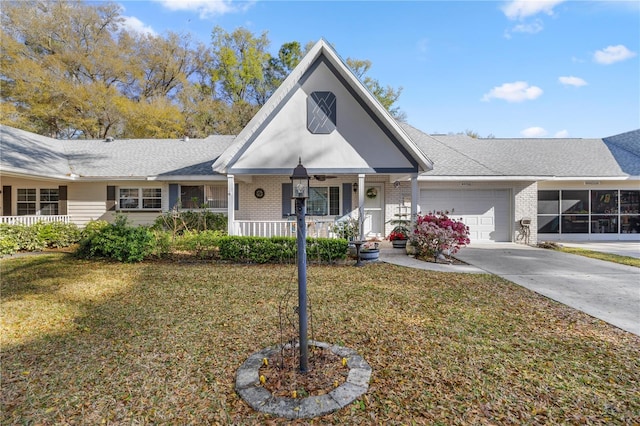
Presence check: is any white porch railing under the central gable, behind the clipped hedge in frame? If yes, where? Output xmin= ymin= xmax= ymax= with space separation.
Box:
xmin=234 ymin=218 xmax=335 ymax=238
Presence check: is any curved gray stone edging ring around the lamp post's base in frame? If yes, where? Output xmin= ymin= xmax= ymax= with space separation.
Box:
xmin=236 ymin=341 xmax=371 ymax=419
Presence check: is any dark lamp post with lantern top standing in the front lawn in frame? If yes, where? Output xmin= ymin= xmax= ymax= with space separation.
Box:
xmin=291 ymin=159 xmax=310 ymax=373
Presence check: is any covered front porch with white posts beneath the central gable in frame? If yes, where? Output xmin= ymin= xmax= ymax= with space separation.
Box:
xmin=225 ymin=173 xmax=419 ymax=240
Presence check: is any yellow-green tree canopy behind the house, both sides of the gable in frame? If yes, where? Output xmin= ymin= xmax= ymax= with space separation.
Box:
xmin=0 ymin=0 xmax=404 ymax=138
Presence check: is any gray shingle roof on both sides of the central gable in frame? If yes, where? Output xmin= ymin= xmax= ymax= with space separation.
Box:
xmin=0 ymin=124 xmax=640 ymax=179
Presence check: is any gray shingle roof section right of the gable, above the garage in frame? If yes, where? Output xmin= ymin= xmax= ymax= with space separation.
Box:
xmin=403 ymin=124 xmax=640 ymax=178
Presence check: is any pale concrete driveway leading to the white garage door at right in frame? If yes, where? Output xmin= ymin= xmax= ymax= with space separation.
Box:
xmin=456 ymin=243 xmax=640 ymax=336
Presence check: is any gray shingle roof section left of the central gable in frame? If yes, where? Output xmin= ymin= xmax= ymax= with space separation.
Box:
xmin=0 ymin=126 xmax=234 ymax=178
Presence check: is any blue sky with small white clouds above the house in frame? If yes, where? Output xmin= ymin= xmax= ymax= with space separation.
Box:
xmin=118 ymin=0 xmax=640 ymax=138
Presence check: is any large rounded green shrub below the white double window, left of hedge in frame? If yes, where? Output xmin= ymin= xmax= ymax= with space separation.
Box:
xmin=76 ymin=216 xmax=156 ymax=263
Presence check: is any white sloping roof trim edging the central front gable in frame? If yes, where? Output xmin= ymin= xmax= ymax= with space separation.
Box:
xmin=211 ymin=39 xmax=433 ymax=174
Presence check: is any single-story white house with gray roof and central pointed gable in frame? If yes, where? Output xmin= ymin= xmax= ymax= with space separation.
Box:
xmin=0 ymin=41 xmax=640 ymax=243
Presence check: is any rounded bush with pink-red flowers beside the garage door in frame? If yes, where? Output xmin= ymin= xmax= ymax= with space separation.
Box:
xmin=411 ymin=212 xmax=471 ymax=258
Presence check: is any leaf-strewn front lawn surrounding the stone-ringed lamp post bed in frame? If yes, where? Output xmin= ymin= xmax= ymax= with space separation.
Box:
xmin=0 ymin=254 xmax=640 ymax=425
